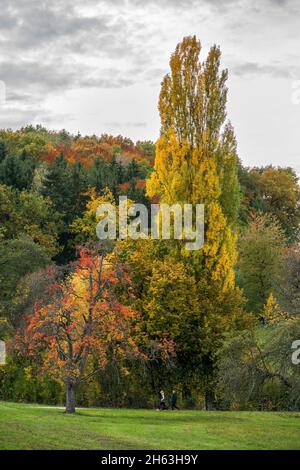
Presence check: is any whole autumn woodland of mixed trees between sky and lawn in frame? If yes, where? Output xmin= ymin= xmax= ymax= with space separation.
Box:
xmin=0 ymin=36 xmax=300 ymax=413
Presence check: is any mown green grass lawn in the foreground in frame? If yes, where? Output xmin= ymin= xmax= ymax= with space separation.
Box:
xmin=0 ymin=402 xmax=300 ymax=450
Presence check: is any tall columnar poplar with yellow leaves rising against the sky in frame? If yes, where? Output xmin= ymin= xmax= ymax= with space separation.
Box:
xmin=147 ymin=36 xmax=242 ymax=401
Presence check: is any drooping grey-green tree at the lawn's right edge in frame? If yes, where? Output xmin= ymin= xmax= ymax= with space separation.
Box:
xmin=218 ymin=319 xmax=300 ymax=411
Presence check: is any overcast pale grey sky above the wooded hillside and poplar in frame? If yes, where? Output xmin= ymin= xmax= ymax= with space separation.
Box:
xmin=0 ymin=0 xmax=300 ymax=172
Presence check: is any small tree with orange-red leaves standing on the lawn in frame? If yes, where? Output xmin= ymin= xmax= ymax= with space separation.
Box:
xmin=15 ymin=247 xmax=138 ymax=413
